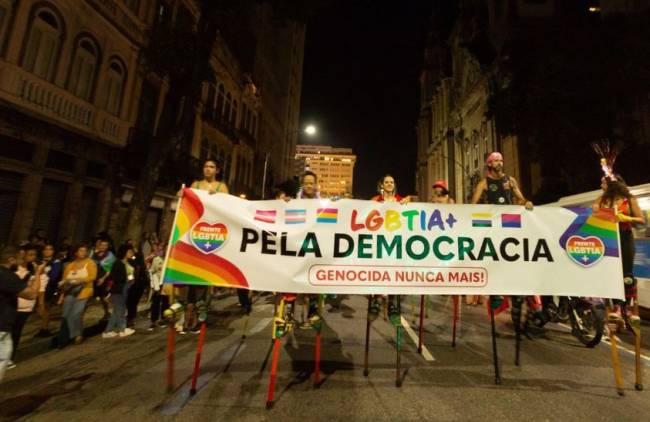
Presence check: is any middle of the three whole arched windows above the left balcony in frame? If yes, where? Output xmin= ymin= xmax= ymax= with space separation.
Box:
xmin=68 ymin=37 xmax=99 ymax=101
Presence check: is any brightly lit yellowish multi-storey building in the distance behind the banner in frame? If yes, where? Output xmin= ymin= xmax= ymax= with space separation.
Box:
xmin=294 ymin=145 xmax=357 ymax=197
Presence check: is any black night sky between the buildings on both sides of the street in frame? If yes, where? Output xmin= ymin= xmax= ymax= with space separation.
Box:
xmin=299 ymin=0 xmax=432 ymax=199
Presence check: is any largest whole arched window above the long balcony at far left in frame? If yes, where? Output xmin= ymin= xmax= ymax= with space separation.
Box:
xmin=23 ymin=8 xmax=63 ymax=81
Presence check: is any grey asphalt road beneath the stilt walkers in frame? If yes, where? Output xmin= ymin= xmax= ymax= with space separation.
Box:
xmin=0 ymin=296 xmax=650 ymax=422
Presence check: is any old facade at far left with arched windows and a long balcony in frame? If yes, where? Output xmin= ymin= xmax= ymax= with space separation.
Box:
xmin=0 ymin=0 xmax=155 ymax=242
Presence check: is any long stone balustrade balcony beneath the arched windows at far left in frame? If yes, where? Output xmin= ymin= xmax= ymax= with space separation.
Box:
xmin=0 ymin=62 xmax=129 ymax=147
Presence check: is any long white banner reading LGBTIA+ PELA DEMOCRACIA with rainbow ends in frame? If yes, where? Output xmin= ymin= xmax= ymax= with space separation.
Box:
xmin=164 ymin=189 xmax=624 ymax=299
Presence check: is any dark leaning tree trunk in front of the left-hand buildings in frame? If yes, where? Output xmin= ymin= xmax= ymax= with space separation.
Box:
xmin=125 ymin=0 xmax=252 ymax=244
